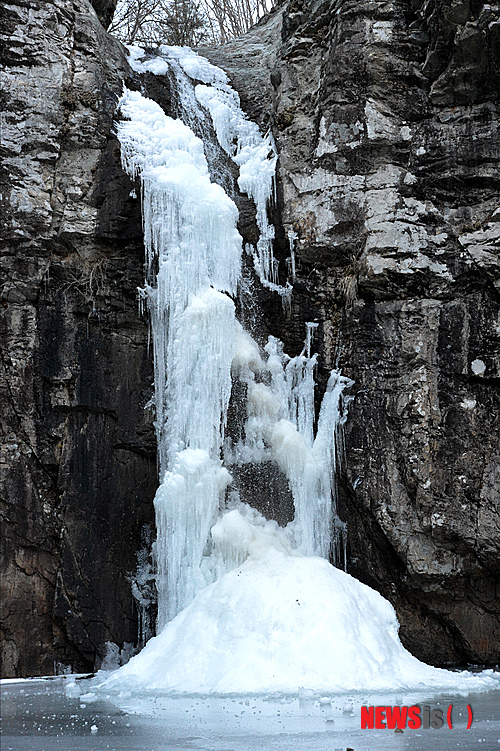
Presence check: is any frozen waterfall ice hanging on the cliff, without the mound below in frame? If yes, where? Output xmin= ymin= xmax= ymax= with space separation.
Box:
xmin=118 ymin=48 xmax=349 ymax=629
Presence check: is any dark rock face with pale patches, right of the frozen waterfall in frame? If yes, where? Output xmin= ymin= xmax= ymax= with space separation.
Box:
xmin=206 ymin=0 xmax=500 ymax=664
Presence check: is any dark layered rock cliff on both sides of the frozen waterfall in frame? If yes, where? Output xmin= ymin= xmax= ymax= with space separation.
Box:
xmin=0 ymin=0 xmax=500 ymax=675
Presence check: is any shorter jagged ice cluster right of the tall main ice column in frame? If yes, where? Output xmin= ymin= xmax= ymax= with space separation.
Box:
xmin=225 ymin=323 xmax=352 ymax=558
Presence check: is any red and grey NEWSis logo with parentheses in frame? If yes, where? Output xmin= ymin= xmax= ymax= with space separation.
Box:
xmin=361 ymin=704 xmax=472 ymax=730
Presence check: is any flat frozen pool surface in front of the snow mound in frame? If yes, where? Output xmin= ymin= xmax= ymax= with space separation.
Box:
xmin=1 ymin=677 xmax=500 ymax=751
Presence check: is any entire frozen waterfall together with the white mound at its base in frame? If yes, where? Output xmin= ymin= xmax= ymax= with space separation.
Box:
xmin=110 ymin=48 xmax=497 ymax=693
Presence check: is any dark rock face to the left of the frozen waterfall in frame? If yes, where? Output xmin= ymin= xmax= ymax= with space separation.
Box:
xmin=1 ymin=0 xmax=156 ymax=676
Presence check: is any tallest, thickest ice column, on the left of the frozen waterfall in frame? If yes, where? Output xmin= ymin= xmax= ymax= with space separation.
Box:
xmin=118 ymin=90 xmax=241 ymax=629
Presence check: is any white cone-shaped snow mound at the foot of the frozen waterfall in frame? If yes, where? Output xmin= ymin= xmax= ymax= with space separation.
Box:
xmin=103 ymin=510 xmax=500 ymax=694
